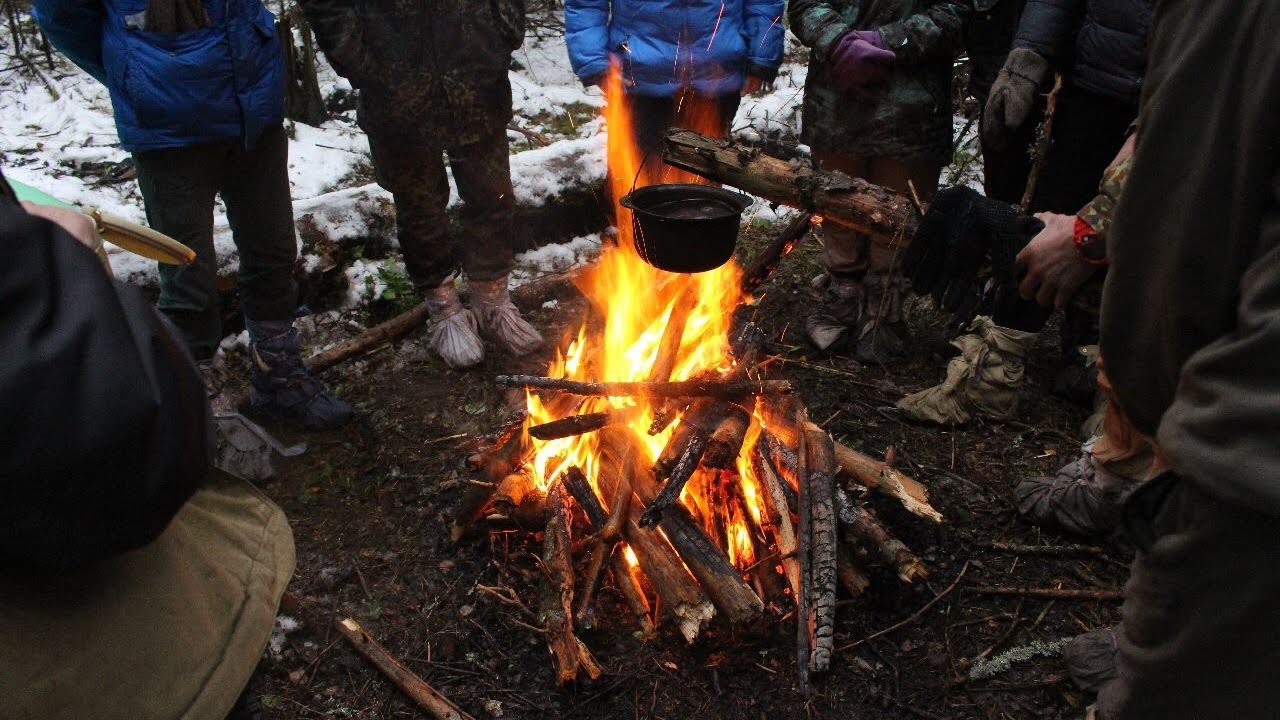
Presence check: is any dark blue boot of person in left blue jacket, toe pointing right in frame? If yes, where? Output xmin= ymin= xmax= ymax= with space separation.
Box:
xmin=244 ymin=319 xmax=355 ymax=430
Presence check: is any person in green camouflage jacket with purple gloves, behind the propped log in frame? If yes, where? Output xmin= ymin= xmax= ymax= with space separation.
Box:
xmin=788 ymin=0 xmax=970 ymax=363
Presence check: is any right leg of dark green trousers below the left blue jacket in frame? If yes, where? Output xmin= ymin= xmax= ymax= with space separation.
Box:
xmin=221 ymin=127 xmax=298 ymax=320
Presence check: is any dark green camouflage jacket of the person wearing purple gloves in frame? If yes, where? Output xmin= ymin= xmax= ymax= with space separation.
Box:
xmin=787 ymin=0 xmax=972 ymax=163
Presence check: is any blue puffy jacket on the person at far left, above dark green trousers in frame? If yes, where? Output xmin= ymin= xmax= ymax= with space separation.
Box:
xmin=32 ymin=0 xmax=284 ymax=151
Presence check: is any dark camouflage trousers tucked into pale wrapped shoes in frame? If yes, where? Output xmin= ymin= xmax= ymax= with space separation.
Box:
xmin=369 ymin=128 xmax=516 ymax=290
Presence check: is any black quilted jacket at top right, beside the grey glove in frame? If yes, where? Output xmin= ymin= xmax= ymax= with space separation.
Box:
xmin=1014 ymin=0 xmax=1153 ymax=105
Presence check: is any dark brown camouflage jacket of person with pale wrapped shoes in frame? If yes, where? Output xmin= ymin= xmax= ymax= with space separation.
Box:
xmin=300 ymin=0 xmax=525 ymax=147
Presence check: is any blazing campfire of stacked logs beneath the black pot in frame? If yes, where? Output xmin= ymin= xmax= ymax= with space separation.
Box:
xmin=453 ymin=65 xmax=941 ymax=689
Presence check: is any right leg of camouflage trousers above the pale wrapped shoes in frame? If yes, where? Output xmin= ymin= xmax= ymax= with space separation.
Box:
xmin=449 ymin=129 xmax=516 ymax=282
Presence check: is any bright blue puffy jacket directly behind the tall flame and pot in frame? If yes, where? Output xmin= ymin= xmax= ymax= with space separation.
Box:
xmin=564 ymin=0 xmax=783 ymax=96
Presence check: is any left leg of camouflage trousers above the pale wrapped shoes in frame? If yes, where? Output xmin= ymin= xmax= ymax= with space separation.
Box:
xmin=369 ymin=136 xmax=458 ymax=291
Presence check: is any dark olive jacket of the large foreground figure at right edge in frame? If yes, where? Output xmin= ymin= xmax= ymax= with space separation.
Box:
xmin=1101 ymin=0 xmax=1280 ymax=515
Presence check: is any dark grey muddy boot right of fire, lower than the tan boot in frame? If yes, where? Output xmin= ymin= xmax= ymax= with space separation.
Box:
xmin=1014 ymin=442 xmax=1139 ymax=539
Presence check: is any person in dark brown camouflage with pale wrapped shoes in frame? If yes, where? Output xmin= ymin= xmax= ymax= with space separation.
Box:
xmin=298 ymin=0 xmax=543 ymax=368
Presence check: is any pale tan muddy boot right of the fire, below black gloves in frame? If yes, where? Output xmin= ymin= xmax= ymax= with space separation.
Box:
xmin=897 ymin=316 xmax=1036 ymax=425
